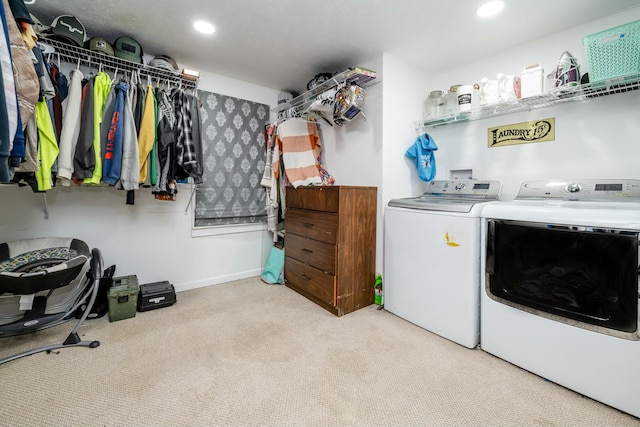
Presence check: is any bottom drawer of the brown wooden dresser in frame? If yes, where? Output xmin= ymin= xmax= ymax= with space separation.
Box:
xmin=284 ymin=256 xmax=335 ymax=305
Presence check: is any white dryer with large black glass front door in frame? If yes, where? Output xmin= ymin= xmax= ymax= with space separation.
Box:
xmin=481 ymin=180 xmax=640 ymax=417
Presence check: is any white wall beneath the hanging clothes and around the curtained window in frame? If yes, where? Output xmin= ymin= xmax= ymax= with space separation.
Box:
xmin=0 ymin=72 xmax=278 ymax=291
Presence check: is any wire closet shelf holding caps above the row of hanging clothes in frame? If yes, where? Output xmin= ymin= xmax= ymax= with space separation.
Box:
xmin=40 ymin=37 xmax=198 ymax=90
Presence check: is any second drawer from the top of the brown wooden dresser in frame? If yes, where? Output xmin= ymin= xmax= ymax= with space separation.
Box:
xmin=284 ymin=209 xmax=338 ymax=245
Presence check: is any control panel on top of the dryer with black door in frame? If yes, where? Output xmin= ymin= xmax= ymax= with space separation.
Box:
xmin=516 ymin=179 xmax=640 ymax=202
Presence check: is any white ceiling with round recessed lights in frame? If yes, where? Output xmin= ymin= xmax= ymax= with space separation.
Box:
xmin=26 ymin=0 xmax=640 ymax=92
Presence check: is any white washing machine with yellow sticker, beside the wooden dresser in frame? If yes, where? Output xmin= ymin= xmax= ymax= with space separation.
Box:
xmin=383 ymin=180 xmax=501 ymax=348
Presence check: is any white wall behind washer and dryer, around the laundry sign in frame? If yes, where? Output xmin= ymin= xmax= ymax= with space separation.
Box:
xmin=384 ymin=4 xmax=640 ymax=200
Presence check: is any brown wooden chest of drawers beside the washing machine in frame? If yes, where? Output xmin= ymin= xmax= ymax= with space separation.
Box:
xmin=284 ymin=186 xmax=377 ymax=316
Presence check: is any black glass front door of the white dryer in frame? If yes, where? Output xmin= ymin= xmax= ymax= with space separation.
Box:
xmin=485 ymin=219 xmax=639 ymax=340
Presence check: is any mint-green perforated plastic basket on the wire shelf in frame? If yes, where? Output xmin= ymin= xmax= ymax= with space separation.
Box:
xmin=582 ymin=20 xmax=640 ymax=85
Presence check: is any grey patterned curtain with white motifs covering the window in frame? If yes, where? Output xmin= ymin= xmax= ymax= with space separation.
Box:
xmin=194 ymin=91 xmax=269 ymax=227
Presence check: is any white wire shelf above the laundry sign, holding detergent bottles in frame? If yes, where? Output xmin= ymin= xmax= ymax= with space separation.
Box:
xmin=412 ymin=74 xmax=640 ymax=133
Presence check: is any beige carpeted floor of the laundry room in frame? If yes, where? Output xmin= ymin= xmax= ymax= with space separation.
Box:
xmin=0 ymin=278 xmax=640 ymax=427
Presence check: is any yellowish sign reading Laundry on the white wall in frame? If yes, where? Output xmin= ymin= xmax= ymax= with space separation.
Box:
xmin=488 ymin=118 xmax=556 ymax=148
